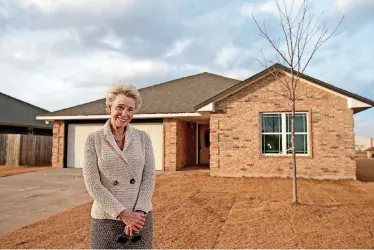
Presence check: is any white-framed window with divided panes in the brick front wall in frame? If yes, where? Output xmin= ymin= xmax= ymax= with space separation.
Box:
xmin=261 ymin=112 xmax=308 ymax=155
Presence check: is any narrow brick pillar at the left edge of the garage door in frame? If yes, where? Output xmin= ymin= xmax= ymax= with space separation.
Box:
xmin=52 ymin=121 xmax=65 ymax=168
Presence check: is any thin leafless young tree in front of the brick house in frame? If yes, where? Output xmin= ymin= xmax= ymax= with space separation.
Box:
xmin=252 ymin=0 xmax=344 ymax=203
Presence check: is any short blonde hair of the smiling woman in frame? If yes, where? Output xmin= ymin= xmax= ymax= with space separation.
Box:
xmin=105 ymin=84 xmax=142 ymax=114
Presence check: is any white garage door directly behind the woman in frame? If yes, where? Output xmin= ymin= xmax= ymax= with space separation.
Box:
xmin=67 ymin=122 xmax=164 ymax=170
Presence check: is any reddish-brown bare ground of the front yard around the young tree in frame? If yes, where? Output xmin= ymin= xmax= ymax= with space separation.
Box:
xmin=0 ymin=175 xmax=374 ymax=249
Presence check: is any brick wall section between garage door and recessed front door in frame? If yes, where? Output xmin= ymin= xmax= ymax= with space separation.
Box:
xmin=164 ymin=119 xmax=196 ymax=171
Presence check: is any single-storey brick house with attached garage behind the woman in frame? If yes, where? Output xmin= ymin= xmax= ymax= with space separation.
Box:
xmin=38 ymin=64 xmax=374 ymax=179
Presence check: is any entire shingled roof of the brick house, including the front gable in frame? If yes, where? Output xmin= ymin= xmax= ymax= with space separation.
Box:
xmin=38 ymin=64 xmax=374 ymax=118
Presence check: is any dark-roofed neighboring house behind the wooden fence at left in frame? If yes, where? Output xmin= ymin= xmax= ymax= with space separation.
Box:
xmin=0 ymin=93 xmax=52 ymax=136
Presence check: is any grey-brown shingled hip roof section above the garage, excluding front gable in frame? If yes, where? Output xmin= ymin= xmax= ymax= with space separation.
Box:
xmin=39 ymin=72 xmax=240 ymax=117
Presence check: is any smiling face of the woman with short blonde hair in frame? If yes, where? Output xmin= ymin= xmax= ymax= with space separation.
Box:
xmin=110 ymin=94 xmax=135 ymax=128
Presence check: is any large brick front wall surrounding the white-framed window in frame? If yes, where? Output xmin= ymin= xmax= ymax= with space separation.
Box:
xmin=210 ymin=74 xmax=356 ymax=179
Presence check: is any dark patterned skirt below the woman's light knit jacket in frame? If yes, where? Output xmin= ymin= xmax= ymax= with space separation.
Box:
xmin=90 ymin=212 xmax=153 ymax=249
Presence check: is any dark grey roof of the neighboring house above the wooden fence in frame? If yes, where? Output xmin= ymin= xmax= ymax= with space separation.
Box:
xmin=0 ymin=92 xmax=52 ymax=129
